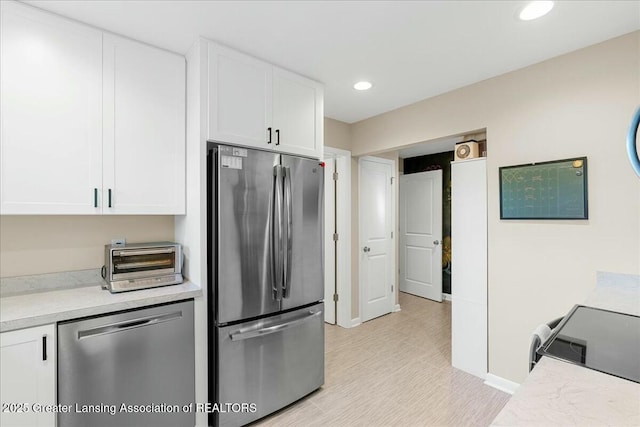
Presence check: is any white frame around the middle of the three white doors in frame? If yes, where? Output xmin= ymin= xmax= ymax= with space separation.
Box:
xmin=354 ymin=156 xmax=400 ymax=325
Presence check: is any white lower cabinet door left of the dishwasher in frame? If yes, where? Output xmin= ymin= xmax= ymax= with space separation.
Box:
xmin=0 ymin=325 xmax=56 ymax=427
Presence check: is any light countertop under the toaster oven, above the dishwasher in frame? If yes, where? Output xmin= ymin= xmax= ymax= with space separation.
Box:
xmin=0 ymin=282 xmax=202 ymax=332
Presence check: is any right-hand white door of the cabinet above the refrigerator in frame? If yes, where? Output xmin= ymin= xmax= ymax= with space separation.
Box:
xmin=273 ymin=67 xmax=324 ymax=158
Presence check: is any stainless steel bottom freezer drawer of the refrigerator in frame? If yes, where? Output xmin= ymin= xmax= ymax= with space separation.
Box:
xmin=212 ymin=303 xmax=324 ymax=426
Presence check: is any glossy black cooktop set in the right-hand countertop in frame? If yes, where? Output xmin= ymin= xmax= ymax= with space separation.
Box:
xmin=538 ymin=305 xmax=640 ymax=383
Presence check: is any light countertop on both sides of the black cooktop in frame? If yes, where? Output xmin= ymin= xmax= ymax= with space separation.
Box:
xmin=491 ymin=272 xmax=640 ymax=426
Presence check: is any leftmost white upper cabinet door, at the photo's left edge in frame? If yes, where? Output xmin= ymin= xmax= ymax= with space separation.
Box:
xmin=0 ymin=1 xmax=102 ymax=214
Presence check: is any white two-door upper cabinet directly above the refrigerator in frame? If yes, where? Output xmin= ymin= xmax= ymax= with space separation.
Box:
xmin=208 ymin=42 xmax=324 ymax=158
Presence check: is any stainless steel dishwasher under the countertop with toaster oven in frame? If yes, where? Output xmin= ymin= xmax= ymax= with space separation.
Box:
xmin=58 ymin=300 xmax=195 ymax=427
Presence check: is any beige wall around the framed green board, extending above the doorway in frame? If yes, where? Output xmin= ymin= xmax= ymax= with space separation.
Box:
xmin=351 ymin=32 xmax=640 ymax=382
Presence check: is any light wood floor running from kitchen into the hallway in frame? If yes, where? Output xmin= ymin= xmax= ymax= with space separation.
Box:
xmin=255 ymin=293 xmax=509 ymax=427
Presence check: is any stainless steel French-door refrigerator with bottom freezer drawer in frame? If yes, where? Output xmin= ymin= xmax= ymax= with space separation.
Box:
xmin=207 ymin=143 xmax=324 ymax=426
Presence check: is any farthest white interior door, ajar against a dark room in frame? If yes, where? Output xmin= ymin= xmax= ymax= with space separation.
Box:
xmin=399 ymin=170 xmax=442 ymax=302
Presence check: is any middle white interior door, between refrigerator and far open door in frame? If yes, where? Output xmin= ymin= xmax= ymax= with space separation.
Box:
xmin=359 ymin=157 xmax=395 ymax=322
